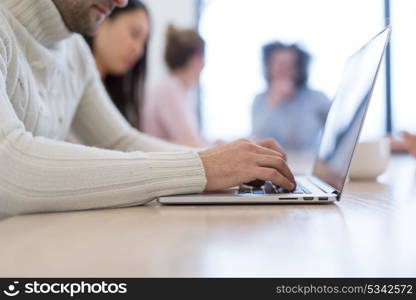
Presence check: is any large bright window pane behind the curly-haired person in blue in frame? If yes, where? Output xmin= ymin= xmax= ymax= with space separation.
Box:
xmin=200 ymin=0 xmax=386 ymax=140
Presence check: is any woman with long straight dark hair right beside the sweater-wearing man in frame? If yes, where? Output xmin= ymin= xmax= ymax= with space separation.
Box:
xmin=85 ymin=0 xmax=150 ymax=129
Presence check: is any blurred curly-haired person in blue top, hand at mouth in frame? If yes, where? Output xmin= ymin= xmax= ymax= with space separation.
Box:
xmin=252 ymin=42 xmax=330 ymax=151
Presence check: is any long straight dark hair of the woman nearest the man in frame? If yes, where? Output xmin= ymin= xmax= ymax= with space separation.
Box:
xmin=84 ymin=0 xmax=149 ymax=129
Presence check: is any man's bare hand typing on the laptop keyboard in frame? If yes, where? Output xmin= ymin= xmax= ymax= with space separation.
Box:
xmin=200 ymin=139 xmax=296 ymax=191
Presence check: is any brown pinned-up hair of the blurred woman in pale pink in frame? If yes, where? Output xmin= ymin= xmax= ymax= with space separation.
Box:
xmin=165 ymin=25 xmax=205 ymax=71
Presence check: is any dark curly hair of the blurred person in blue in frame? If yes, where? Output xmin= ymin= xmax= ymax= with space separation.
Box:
xmin=263 ymin=41 xmax=311 ymax=88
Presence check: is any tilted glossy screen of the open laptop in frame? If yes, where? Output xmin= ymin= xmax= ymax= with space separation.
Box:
xmin=313 ymin=28 xmax=391 ymax=191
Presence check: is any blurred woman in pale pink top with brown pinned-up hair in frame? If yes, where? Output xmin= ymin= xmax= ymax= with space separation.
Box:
xmin=142 ymin=25 xmax=214 ymax=147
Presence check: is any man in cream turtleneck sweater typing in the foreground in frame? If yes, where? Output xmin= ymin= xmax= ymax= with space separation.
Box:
xmin=0 ymin=0 xmax=294 ymax=214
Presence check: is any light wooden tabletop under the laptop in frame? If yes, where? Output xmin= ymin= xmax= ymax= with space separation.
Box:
xmin=0 ymin=156 xmax=416 ymax=277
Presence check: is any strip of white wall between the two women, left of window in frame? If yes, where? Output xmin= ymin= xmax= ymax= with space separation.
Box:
xmin=143 ymin=0 xmax=197 ymax=87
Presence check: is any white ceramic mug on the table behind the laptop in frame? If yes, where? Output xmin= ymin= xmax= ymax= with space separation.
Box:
xmin=349 ymin=138 xmax=390 ymax=180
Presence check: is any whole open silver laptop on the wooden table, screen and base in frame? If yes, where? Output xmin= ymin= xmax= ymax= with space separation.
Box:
xmin=159 ymin=27 xmax=391 ymax=204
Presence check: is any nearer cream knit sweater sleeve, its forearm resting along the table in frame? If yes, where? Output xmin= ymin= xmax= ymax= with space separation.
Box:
xmin=0 ymin=39 xmax=206 ymax=215
